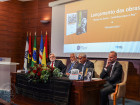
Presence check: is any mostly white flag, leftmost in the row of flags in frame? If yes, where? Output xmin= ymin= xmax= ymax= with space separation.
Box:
xmin=24 ymin=34 xmax=29 ymax=73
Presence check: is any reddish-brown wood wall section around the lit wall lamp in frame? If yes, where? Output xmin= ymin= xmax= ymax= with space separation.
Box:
xmin=23 ymin=0 xmax=54 ymax=66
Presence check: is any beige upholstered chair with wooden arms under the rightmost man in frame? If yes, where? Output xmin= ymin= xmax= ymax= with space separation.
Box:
xmin=109 ymin=61 xmax=128 ymax=105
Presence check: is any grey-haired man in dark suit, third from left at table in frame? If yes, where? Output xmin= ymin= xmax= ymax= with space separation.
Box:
xmin=77 ymin=53 xmax=94 ymax=77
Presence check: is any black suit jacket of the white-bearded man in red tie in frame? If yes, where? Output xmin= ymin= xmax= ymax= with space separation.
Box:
xmin=47 ymin=60 xmax=66 ymax=73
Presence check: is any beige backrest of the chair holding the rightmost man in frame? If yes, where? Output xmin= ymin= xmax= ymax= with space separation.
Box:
xmin=118 ymin=61 xmax=128 ymax=83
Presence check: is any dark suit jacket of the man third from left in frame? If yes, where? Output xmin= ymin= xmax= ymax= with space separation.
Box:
xmin=77 ymin=60 xmax=94 ymax=77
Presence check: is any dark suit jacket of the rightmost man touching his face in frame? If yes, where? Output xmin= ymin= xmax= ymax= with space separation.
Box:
xmin=100 ymin=61 xmax=123 ymax=86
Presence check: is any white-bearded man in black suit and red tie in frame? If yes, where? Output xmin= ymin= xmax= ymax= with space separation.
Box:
xmin=47 ymin=53 xmax=66 ymax=73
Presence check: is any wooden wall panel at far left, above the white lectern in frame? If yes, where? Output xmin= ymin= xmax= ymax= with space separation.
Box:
xmin=0 ymin=0 xmax=24 ymax=69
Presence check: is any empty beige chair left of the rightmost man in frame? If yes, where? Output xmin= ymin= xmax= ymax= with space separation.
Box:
xmin=90 ymin=60 xmax=104 ymax=78
